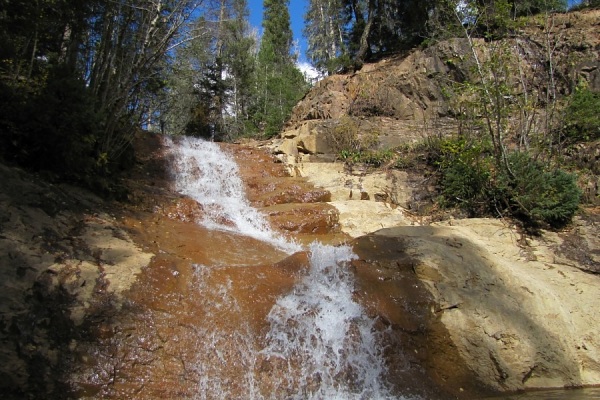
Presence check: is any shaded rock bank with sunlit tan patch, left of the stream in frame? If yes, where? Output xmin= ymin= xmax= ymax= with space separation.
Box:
xmin=0 ymin=165 xmax=153 ymax=398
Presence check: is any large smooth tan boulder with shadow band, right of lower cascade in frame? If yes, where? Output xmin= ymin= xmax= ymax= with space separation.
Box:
xmin=375 ymin=219 xmax=600 ymax=391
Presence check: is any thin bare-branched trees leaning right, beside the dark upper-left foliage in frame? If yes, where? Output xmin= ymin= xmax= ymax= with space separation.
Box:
xmin=86 ymin=0 xmax=199 ymax=164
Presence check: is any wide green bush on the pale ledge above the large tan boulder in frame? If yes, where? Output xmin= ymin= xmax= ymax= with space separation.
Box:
xmin=433 ymin=138 xmax=581 ymax=228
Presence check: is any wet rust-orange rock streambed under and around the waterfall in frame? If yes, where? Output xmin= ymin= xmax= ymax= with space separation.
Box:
xmin=65 ymin=135 xmax=473 ymax=399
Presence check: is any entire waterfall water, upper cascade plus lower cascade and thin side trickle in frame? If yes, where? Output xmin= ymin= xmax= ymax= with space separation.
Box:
xmin=163 ymin=138 xmax=412 ymax=399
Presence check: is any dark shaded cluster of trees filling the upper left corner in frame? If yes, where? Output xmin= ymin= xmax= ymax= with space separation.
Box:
xmin=0 ymin=0 xmax=201 ymax=191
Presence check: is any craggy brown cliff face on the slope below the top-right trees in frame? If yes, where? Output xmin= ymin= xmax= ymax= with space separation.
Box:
xmin=275 ymin=10 xmax=600 ymax=163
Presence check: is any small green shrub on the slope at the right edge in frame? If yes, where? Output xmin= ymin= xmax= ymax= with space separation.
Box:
xmin=565 ymin=84 xmax=600 ymax=141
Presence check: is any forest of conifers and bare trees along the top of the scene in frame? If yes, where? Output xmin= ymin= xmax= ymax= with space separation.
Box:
xmin=0 ymin=0 xmax=600 ymax=222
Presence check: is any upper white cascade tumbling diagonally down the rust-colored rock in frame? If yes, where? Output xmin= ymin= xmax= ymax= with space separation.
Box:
xmin=165 ymin=137 xmax=301 ymax=254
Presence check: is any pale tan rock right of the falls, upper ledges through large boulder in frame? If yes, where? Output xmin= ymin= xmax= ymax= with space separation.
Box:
xmin=278 ymin=150 xmax=600 ymax=393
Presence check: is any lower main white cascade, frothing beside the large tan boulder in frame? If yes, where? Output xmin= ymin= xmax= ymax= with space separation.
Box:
xmin=261 ymin=243 xmax=396 ymax=399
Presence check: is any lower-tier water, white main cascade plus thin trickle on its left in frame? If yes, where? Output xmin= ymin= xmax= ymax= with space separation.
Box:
xmin=190 ymin=243 xmax=407 ymax=400
